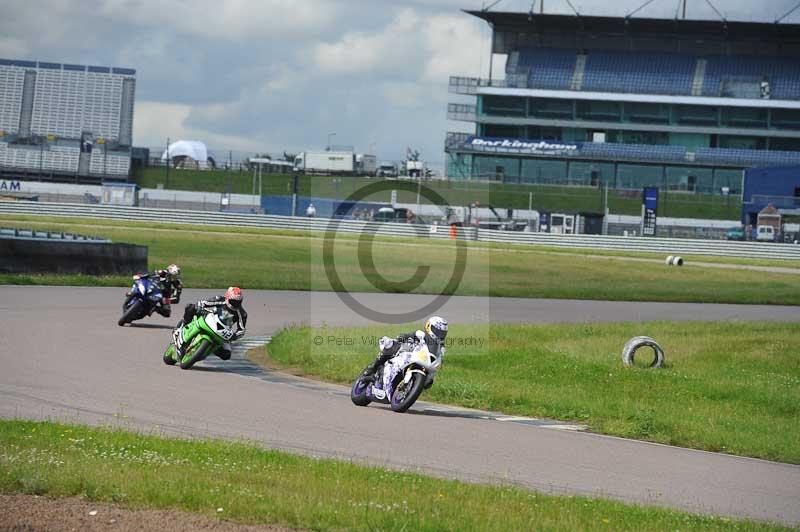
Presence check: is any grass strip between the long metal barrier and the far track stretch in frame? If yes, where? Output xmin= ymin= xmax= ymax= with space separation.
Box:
xmin=0 ymin=217 xmax=800 ymax=305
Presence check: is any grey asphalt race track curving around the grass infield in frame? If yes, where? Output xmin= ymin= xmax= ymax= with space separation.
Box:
xmin=0 ymin=286 xmax=800 ymax=525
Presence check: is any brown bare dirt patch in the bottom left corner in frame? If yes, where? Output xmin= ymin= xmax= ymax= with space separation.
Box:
xmin=0 ymin=494 xmax=290 ymax=532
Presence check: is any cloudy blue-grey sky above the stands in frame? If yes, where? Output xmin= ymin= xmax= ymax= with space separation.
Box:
xmin=0 ymin=0 xmax=800 ymax=168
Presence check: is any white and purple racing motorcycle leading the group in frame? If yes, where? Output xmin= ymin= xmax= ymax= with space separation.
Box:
xmin=350 ymin=342 xmax=444 ymax=412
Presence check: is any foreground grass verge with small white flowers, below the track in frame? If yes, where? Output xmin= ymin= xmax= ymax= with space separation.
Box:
xmin=0 ymin=421 xmax=779 ymax=531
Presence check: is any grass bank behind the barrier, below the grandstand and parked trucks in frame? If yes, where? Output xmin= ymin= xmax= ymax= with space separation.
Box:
xmin=136 ymin=168 xmax=741 ymax=220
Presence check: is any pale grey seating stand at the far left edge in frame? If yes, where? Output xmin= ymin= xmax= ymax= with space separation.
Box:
xmin=0 ymin=59 xmax=136 ymax=182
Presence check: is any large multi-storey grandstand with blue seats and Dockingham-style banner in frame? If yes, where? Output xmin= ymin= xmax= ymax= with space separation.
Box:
xmin=445 ymin=11 xmax=800 ymax=194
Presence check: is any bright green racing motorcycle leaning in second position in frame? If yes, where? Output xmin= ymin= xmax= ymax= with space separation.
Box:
xmin=164 ymin=308 xmax=239 ymax=369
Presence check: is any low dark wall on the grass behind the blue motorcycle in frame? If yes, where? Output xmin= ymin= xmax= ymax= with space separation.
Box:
xmin=0 ymin=238 xmax=147 ymax=275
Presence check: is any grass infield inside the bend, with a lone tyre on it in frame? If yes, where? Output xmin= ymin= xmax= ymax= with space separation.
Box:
xmin=266 ymin=322 xmax=800 ymax=464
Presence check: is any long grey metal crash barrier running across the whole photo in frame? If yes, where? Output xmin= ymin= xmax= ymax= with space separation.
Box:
xmin=0 ymin=201 xmax=800 ymax=260
